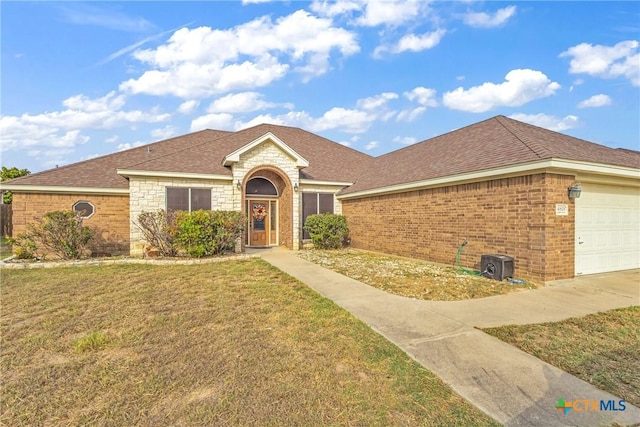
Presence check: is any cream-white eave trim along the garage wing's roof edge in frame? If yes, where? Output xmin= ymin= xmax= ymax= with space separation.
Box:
xmin=337 ymin=159 xmax=640 ymax=200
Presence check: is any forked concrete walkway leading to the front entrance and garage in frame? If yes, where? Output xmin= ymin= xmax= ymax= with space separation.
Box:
xmin=260 ymin=249 xmax=640 ymax=426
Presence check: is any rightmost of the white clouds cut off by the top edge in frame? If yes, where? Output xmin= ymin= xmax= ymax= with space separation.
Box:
xmin=355 ymin=0 xmax=427 ymax=27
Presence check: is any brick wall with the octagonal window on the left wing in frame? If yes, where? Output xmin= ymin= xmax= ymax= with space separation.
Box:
xmin=12 ymin=191 xmax=129 ymax=255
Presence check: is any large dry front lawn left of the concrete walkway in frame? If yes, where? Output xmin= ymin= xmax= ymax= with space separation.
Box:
xmin=0 ymin=259 xmax=495 ymax=426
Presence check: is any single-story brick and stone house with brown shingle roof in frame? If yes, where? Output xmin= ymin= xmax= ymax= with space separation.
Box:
xmin=1 ymin=116 xmax=640 ymax=281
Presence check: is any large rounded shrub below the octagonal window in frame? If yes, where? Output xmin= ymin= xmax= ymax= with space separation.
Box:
xmin=27 ymin=211 xmax=94 ymax=259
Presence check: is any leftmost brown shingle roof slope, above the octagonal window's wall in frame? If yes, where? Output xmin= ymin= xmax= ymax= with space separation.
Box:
xmin=3 ymin=130 xmax=229 ymax=188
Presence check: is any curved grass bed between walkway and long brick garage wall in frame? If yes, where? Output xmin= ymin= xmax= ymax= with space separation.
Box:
xmin=297 ymin=249 xmax=536 ymax=301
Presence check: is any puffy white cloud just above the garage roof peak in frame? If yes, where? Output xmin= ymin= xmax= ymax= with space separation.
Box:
xmin=442 ymin=69 xmax=560 ymax=113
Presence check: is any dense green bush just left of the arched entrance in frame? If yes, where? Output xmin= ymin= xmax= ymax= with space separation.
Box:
xmin=175 ymin=210 xmax=245 ymax=258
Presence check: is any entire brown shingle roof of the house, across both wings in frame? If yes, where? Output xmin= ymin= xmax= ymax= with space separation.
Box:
xmin=3 ymin=116 xmax=640 ymax=194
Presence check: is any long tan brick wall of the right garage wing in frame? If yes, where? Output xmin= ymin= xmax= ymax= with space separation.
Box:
xmin=342 ymin=173 xmax=575 ymax=281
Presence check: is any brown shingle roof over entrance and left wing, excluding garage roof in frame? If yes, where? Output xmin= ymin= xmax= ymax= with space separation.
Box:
xmin=3 ymin=124 xmax=373 ymax=188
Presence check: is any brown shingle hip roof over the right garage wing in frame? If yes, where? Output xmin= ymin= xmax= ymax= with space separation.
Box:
xmin=342 ymin=116 xmax=640 ymax=194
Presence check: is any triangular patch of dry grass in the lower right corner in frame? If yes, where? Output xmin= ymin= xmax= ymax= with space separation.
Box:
xmin=483 ymin=306 xmax=640 ymax=406
